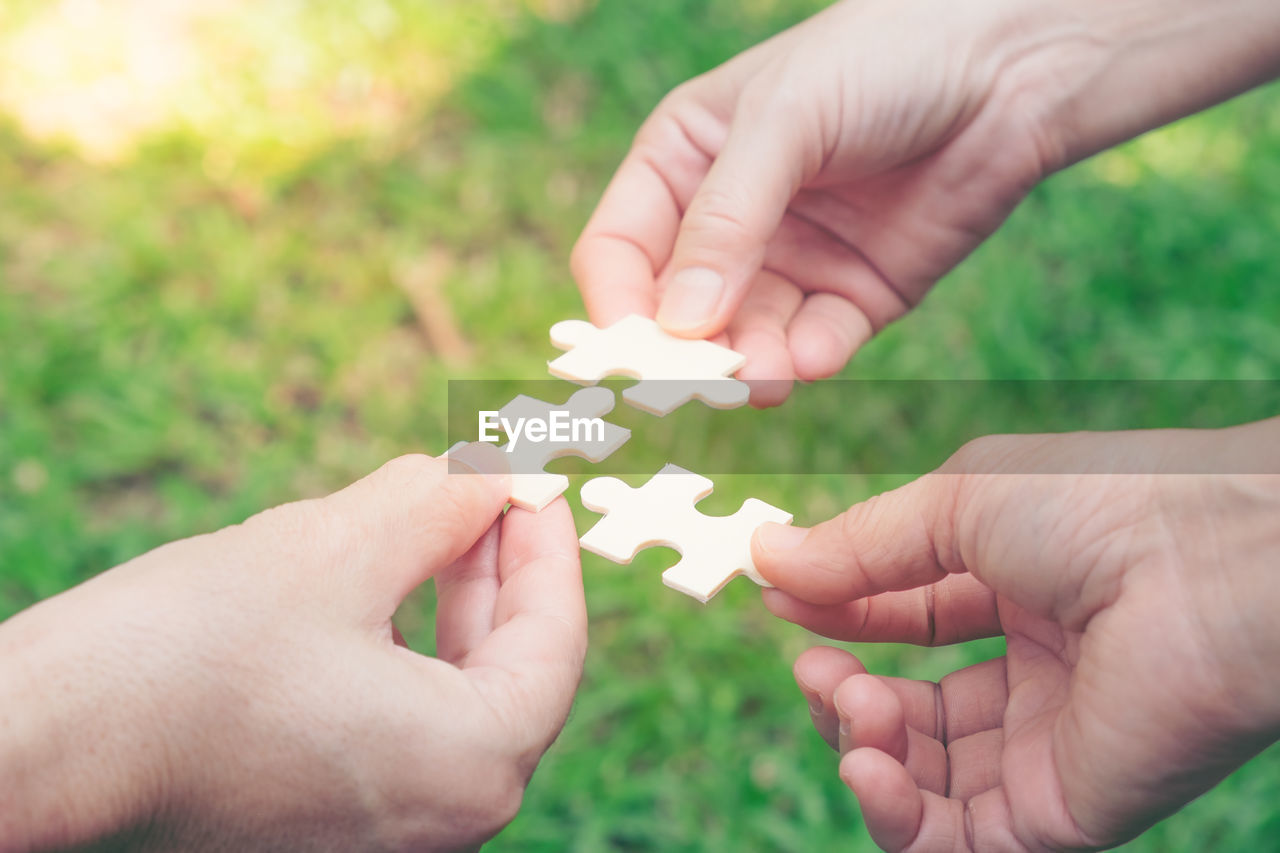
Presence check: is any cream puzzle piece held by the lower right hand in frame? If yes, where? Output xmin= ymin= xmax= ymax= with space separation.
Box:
xmin=581 ymin=465 xmax=791 ymax=603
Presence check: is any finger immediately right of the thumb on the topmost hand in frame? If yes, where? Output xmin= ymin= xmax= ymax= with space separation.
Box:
xmin=728 ymin=270 xmax=801 ymax=409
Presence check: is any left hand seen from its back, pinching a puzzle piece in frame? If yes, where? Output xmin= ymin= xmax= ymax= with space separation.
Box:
xmin=0 ymin=448 xmax=586 ymax=850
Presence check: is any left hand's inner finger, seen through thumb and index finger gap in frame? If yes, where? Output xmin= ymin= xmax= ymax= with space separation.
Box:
xmin=435 ymin=520 xmax=502 ymax=666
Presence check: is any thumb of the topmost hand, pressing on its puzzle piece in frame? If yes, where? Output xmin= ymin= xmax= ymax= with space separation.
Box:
xmin=657 ymin=91 xmax=805 ymax=338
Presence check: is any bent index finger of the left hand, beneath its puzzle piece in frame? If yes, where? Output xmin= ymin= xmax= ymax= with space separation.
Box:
xmin=465 ymin=498 xmax=586 ymax=752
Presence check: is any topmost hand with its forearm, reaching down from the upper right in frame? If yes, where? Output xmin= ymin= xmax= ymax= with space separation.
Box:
xmin=572 ymin=0 xmax=1280 ymax=406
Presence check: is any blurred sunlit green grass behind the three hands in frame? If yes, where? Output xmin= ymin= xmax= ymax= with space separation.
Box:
xmin=0 ymin=0 xmax=1280 ymax=850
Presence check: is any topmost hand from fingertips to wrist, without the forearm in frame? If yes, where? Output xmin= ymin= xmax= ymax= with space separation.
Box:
xmin=573 ymin=1 xmax=1044 ymax=405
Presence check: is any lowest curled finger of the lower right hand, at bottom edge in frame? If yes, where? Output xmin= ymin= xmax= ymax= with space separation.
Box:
xmin=840 ymin=748 xmax=967 ymax=853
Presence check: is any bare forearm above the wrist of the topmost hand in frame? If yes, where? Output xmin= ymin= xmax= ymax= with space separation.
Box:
xmin=995 ymin=0 xmax=1280 ymax=173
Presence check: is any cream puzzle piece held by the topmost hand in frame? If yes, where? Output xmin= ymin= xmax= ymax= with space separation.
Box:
xmin=547 ymin=314 xmax=750 ymax=415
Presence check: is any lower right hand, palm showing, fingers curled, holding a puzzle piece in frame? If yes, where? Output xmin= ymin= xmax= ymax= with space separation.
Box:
xmin=754 ymin=419 xmax=1280 ymax=853
